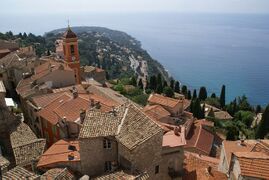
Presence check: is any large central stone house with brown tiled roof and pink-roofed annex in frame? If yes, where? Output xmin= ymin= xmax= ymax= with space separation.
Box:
xmin=79 ymin=104 xmax=185 ymax=179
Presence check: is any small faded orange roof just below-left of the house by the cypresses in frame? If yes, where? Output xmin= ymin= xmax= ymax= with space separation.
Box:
xmin=143 ymin=105 xmax=170 ymax=121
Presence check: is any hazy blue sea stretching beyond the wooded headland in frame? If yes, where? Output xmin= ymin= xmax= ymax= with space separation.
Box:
xmin=0 ymin=13 xmax=269 ymax=105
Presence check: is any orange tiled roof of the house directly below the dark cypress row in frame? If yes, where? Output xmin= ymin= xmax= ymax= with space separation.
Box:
xmin=148 ymin=93 xmax=181 ymax=108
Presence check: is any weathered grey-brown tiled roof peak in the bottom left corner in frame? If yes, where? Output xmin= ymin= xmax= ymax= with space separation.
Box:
xmin=2 ymin=166 xmax=39 ymax=180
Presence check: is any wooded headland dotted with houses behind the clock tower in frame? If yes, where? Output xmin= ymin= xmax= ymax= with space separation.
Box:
xmin=44 ymin=27 xmax=168 ymax=79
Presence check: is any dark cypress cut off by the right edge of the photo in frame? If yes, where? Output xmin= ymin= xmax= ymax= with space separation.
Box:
xmin=255 ymin=104 xmax=269 ymax=139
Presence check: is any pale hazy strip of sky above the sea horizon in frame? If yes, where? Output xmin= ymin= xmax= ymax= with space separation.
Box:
xmin=0 ymin=0 xmax=269 ymax=14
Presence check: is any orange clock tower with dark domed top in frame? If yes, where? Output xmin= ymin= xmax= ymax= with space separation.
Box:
xmin=63 ymin=25 xmax=81 ymax=84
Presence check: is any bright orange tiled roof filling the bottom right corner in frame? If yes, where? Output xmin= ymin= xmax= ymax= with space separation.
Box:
xmin=233 ymin=152 xmax=269 ymax=179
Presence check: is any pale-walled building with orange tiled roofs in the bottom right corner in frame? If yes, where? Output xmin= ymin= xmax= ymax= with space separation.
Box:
xmin=218 ymin=140 xmax=269 ymax=179
